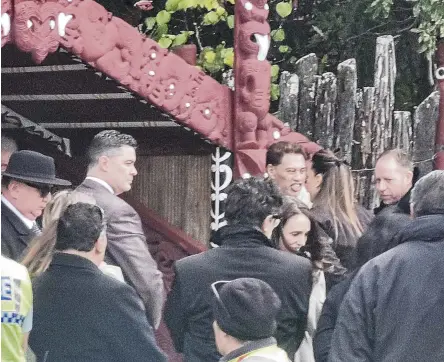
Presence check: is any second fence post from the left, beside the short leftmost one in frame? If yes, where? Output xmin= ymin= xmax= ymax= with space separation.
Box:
xmin=295 ymin=53 xmax=318 ymax=138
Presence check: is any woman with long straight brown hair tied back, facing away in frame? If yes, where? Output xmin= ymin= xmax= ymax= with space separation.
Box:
xmin=306 ymin=150 xmax=372 ymax=269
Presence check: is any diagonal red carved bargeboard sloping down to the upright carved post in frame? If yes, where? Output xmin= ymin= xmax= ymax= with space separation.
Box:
xmin=10 ymin=0 xmax=233 ymax=147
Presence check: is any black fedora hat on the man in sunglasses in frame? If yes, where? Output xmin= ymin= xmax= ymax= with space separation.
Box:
xmin=2 ymin=150 xmax=71 ymax=186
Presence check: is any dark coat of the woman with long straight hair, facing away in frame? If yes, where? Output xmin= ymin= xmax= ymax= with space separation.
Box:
xmin=311 ymin=204 xmax=373 ymax=270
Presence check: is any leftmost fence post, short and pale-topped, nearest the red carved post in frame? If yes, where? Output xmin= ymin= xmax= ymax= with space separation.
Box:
xmin=279 ymin=71 xmax=299 ymax=130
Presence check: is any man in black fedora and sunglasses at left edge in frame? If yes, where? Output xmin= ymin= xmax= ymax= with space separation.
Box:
xmin=1 ymin=150 xmax=71 ymax=261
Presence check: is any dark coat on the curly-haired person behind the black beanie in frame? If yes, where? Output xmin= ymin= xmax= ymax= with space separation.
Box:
xmin=165 ymin=226 xmax=312 ymax=362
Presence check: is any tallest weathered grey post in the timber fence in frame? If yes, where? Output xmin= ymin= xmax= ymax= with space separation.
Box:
xmin=373 ymin=35 xmax=396 ymax=154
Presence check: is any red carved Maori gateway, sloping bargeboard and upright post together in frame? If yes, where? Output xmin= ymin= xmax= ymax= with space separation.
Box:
xmin=1 ymin=0 xmax=318 ymax=175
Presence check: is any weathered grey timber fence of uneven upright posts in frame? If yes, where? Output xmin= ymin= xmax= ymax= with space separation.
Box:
xmin=278 ymin=36 xmax=439 ymax=208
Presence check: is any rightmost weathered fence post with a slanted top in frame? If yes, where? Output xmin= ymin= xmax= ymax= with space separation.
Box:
xmin=413 ymin=91 xmax=439 ymax=175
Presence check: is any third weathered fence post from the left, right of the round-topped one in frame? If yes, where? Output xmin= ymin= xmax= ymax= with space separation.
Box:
xmin=313 ymin=72 xmax=337 ymax=149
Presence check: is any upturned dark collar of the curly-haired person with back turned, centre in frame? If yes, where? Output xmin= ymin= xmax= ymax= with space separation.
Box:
xmin=211 ymin=225 xmax=272 ymax=247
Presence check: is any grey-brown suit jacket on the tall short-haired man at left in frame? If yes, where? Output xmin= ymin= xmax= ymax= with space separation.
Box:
xmin=77 ymin=179 xmax=165 ymax=328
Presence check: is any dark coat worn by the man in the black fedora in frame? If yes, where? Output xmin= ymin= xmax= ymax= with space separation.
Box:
xmin=2 ymin=202 xmax=36 ymax=261
